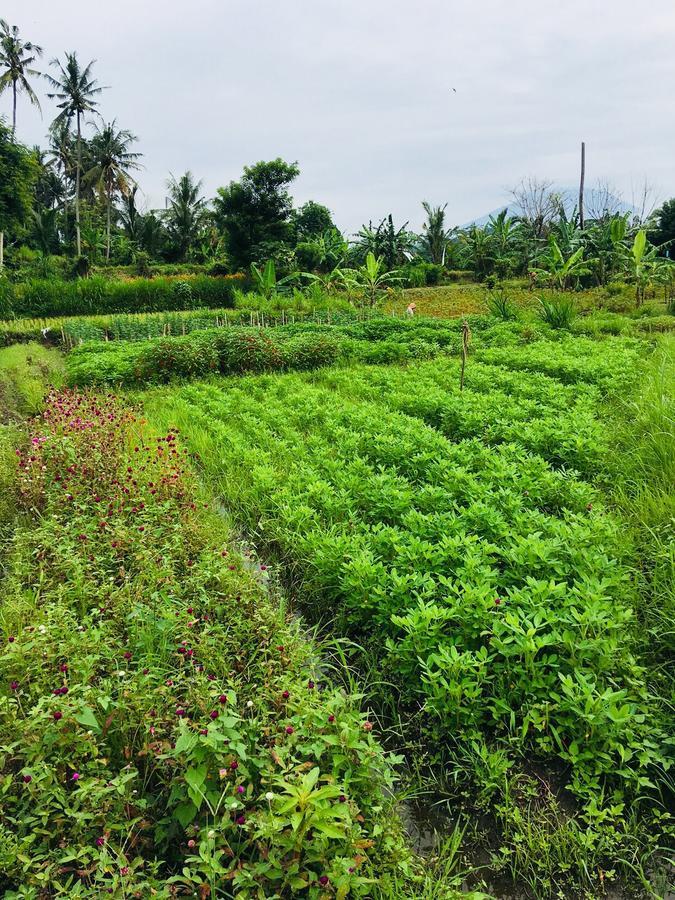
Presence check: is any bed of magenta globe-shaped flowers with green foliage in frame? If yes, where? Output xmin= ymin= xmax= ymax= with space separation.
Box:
xmin=0 ymin=390 xmax=406 ymax=898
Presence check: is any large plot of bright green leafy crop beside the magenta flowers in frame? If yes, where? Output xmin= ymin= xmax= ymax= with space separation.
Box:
xmin=141 ymin=337 xmax=673 ymax=897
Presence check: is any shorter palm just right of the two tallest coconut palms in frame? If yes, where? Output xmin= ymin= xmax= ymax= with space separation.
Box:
xmin=84 ymin=119 xmax=142 ymax=260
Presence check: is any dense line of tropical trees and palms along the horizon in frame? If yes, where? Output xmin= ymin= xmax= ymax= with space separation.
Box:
xmin=0 ymin=14 xmax=675 ymax=302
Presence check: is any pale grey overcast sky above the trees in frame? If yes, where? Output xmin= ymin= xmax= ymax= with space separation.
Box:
xmin=5 ymin=0 xmax=675 ymax=232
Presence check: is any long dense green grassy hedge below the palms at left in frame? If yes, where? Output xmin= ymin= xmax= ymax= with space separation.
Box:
xmin=0 ymin=275 xmax=245 ymax=319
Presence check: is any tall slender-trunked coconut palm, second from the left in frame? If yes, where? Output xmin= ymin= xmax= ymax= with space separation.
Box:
xmin=45 ymin=53 xmax=104 ymax=256
